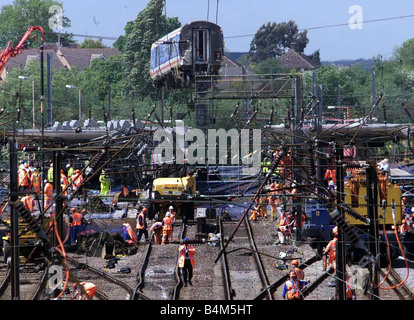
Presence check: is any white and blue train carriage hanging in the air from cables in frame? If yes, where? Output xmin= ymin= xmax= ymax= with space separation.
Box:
xmin=150 ymin=21 xmax=224 ymax=86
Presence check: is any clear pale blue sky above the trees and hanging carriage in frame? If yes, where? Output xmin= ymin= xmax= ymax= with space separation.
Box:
xmin=0 ymin=0 xmax=414 ymax=61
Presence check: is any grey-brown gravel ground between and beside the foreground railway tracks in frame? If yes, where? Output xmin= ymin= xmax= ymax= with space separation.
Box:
xmin=61 ymin=215 xmax=414 ymax=300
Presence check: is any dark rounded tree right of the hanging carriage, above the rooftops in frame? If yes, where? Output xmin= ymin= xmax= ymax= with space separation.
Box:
xmin=249 ymin=20 xmax=309 ymax=62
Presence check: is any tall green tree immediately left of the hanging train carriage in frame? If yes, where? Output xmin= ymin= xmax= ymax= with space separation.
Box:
xmin=120 ymin=0 xmax=181 ymax=98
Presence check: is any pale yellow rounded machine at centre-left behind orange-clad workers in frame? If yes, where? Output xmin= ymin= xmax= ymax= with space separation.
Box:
xmin=151 ymin=176 xmax=196 ymax=220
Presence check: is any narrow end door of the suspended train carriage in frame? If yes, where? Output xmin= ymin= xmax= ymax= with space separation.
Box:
xmin=193 ymin=29 xmax=210 ymax=74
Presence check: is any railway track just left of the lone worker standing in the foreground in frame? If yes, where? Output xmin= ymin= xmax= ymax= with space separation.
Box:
xmin=133 ymin=222 xmax=186 ymax=300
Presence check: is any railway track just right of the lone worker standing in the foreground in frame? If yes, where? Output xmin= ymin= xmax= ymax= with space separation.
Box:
xmin=220 ymin=218 xmax=274 ymax=300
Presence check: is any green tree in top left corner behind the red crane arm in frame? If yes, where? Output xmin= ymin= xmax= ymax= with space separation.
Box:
xmin=0 ymin=0 xmax=73 ymax=48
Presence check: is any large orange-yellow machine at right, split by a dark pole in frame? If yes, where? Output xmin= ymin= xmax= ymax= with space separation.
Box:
xmin=344 ymin=170 xmax=403 ymax=227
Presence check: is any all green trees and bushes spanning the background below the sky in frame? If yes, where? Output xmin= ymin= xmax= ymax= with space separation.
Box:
xmin=0 ymin=0 xmax=414 ymax=133
